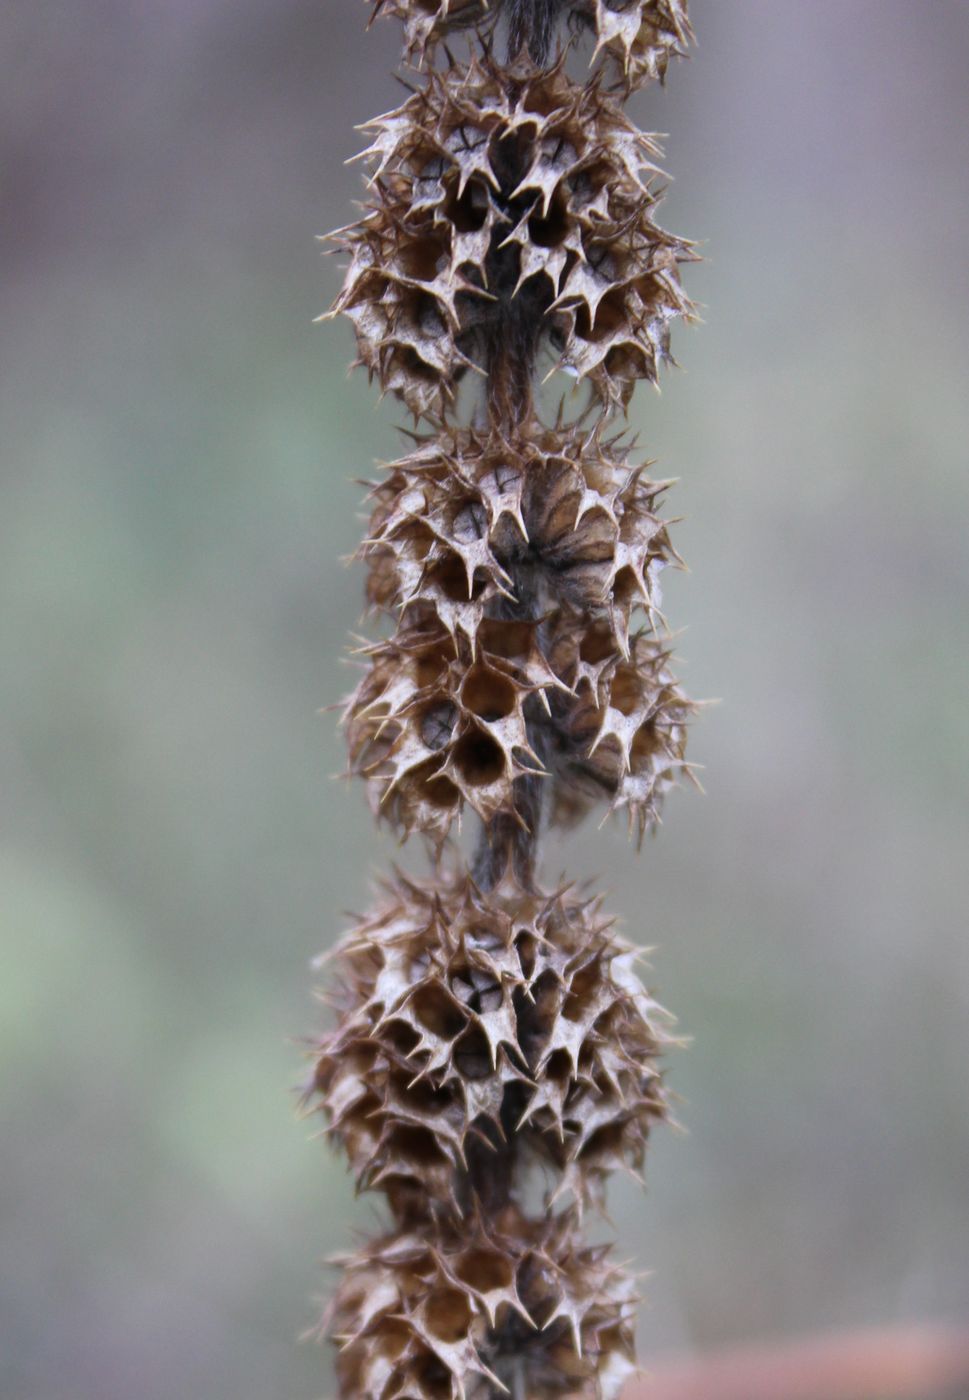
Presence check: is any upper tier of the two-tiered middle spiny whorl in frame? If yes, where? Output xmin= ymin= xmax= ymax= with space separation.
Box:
xmin=360 ymin=423 xmax=679 ymax=654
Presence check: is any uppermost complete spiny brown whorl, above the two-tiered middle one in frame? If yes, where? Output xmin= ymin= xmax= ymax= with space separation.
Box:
xmin=330 ymin=59 xmax=693 ymax=419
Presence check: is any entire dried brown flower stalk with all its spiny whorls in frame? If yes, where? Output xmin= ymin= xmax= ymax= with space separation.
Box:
xmin=308 ymin=0 xmax=692 ymax=1400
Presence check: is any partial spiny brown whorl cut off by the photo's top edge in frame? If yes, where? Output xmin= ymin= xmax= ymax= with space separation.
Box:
xmin=374 ymin=0 xmax=693 ymax=92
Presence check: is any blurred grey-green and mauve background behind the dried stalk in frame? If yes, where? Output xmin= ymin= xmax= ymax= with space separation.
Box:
xmin=0 ymin=0 xmax=969 ymax=1400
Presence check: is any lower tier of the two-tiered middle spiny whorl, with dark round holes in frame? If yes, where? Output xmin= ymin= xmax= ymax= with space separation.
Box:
xmin=344 ymin=609 xmax=693 ymax=844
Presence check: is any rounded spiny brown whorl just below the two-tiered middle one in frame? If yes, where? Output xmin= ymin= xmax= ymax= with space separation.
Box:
xmin=307 ymin=875 xmax=671 ymax=1218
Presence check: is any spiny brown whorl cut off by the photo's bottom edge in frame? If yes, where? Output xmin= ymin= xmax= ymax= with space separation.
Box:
xmin=328 ymin=1207 xmax=636 ymax=1400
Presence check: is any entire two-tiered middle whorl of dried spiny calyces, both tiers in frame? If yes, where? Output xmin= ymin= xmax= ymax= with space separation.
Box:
xmin=346 ymin=421 xmax=692 ymax=840
